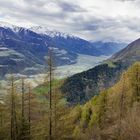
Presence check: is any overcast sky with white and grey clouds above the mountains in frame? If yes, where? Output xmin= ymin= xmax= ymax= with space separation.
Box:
xmin=0 ymin=0 xmax=140 ymax=42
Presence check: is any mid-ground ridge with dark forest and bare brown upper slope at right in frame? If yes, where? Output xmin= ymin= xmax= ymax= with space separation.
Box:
xmin=61 ymin=39 xmax=140 ymax=104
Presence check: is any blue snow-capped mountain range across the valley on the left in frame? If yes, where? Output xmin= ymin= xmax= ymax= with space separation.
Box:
xmin=0 ymin=22 xmax=125 ymax=78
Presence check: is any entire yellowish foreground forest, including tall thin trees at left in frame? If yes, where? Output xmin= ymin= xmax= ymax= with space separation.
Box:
xmin=0 ymin=51 xmax=140 ymax=140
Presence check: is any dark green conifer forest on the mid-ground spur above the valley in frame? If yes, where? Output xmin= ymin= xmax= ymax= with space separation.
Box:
xmin=61 ymin=61 xmax=129 ymax=105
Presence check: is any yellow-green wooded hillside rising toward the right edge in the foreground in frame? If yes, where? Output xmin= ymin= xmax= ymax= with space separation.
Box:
xmin=64 ymin=62 xmax=140 ymax=140
